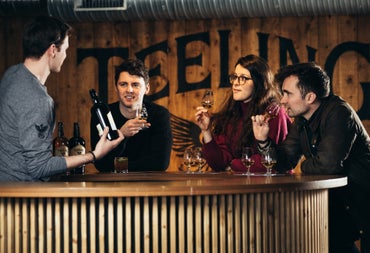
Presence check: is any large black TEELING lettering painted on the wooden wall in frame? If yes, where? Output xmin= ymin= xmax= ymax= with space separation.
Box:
xmin=77 ymin=30 xmax=370 ymax=120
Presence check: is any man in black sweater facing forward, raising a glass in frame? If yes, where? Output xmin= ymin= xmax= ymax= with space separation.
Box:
xmin=90 ymin=59 xmax=172 ymax=172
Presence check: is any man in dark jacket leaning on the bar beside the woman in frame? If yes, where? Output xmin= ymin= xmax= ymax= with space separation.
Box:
xmin=252 ymin=63 xmax=370 ymax=253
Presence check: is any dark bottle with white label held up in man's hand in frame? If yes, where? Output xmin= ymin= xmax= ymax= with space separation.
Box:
xmin=90 ymin=89 xmax=118 ymax=140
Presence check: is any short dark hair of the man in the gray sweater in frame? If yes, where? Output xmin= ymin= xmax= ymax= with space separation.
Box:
xmin=23 ymin=16 xmax=72 ymax=59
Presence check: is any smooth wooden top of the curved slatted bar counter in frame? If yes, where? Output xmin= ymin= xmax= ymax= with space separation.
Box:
xmin=0 ymin=172 xmax=347 ymax=197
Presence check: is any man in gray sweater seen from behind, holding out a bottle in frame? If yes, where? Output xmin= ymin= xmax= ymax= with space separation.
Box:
xmin=0 ymin=17 xmax=124 ymax=181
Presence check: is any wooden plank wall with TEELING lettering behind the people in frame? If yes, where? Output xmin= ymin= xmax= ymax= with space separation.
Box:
xmin=0 ymin=16 xmax=370 ymax=170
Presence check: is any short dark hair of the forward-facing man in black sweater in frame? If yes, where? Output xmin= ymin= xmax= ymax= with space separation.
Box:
xmin=114 ymin=59 xmax=149 ymax=85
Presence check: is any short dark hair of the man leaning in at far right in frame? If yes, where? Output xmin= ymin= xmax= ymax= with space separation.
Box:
xmin=275 ymin=62 xmax=331 ymax=100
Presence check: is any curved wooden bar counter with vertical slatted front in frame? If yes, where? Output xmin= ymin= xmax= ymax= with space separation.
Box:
xmin=0 ymin=172 xmax=347 ymax=253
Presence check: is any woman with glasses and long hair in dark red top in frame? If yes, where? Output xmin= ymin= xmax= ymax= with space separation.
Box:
xmin=195 ymin=55 xmax=291 ymax=173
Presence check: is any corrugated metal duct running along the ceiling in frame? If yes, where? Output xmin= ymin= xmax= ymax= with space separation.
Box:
xmin=0 ymin=0 xmax=370 ymax=22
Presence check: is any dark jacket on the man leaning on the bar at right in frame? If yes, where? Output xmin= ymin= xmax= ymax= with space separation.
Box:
xmin=277 ymin=95 xmax=370 ymax=241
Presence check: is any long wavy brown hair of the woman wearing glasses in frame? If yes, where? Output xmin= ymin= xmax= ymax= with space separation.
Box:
xmin=212 ymin=55 xmax=281 ymax=156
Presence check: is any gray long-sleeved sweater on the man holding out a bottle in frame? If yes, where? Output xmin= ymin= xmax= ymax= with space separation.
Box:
xmin=0 ymin=64 xmax=67 ymax=181
